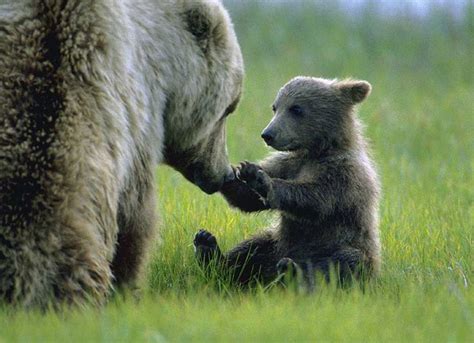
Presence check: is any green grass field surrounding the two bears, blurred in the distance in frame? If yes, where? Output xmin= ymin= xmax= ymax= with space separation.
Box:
xmin=0 ymin=1 xmax=474 ymax=342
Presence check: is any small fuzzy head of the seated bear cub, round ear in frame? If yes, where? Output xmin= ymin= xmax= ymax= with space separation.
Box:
xmin=262 ymin=76 xmax=371 ymax=153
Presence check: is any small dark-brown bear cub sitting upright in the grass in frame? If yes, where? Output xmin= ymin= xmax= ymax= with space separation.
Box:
xmin=194 ymin=77 xmax=380 ymax=284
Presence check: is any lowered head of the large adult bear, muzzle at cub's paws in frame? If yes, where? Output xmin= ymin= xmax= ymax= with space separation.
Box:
xmin=162 ymin=0 xmax=243 ymax=193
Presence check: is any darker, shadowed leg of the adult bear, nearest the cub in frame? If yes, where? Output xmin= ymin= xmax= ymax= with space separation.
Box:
xmin=112 ymin=187 xmax=155 ymax=288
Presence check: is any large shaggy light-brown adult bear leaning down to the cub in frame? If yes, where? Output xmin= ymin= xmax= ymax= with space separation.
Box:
xmin=0 ymin=0 xmax=243 ymax=308
